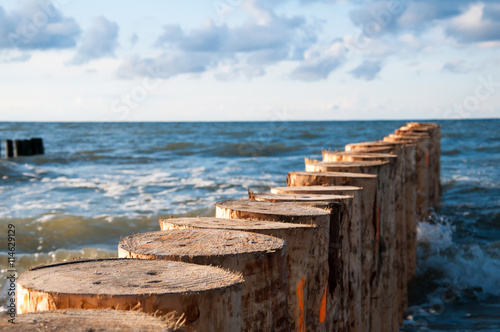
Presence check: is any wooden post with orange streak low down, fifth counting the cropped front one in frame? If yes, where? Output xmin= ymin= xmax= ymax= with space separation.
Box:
xmin=215 ymin=201 xmax=331 ymax=331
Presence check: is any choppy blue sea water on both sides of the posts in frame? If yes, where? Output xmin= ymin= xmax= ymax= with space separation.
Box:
xmin=0 ymin=120 xmax=500 ymax=331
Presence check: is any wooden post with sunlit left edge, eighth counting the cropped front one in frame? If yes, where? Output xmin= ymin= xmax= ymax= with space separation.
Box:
xmin=287 ymin=171 xmax=381 ymax=331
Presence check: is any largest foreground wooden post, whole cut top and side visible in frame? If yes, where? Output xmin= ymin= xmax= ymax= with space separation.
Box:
xmin=16 ymin=258 xmax=243 ymax=331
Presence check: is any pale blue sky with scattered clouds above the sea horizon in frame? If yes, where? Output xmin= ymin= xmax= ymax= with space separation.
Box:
xmin=0 ymin=0 xmax=500 ymax=122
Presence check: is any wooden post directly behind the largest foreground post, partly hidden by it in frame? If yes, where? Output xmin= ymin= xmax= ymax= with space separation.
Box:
xmin=118 ymin=229 xmax=290 ymax=331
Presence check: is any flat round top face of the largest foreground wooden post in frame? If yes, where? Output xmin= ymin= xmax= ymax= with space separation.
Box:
xmin=17 ymin=258 xmax=243 ymax=296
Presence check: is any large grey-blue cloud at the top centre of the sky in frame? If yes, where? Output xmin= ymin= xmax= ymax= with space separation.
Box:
xmin=117 ymin=1 xmax=316 ymax=80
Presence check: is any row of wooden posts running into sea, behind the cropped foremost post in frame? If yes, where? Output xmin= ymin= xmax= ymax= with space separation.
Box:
xmin=12 ymin=123 xmax=440 ymax=332
